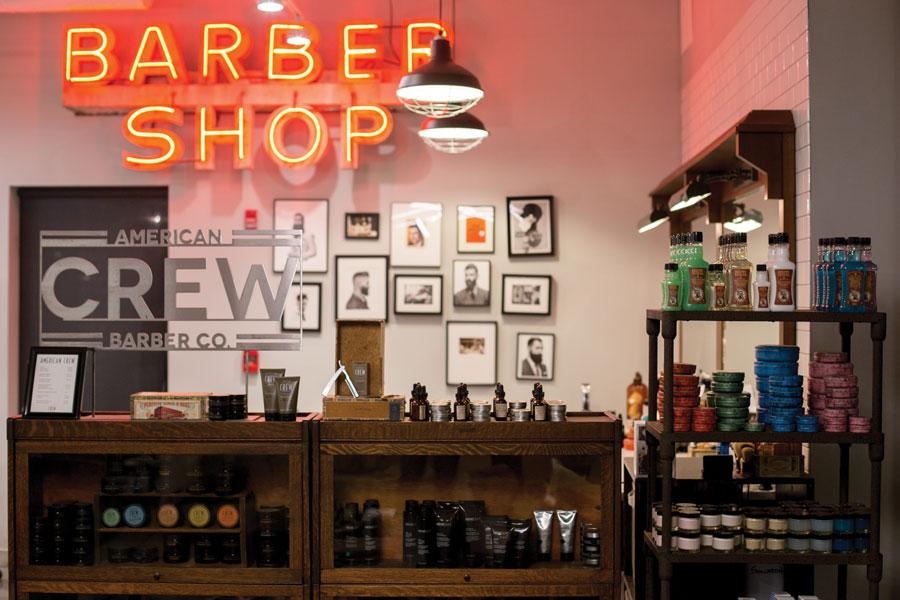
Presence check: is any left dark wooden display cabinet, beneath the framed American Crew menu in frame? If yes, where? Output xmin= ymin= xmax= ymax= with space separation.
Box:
xmin=8 ymin=415 xmax=311 ymax=597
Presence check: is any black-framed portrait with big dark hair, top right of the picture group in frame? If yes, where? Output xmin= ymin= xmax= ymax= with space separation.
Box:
xmin=506 ymin=196 xmax=553 ymax=256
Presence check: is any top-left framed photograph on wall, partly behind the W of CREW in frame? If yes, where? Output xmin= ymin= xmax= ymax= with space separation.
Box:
xmin=272 ymin=198 xmax=328 ymax=273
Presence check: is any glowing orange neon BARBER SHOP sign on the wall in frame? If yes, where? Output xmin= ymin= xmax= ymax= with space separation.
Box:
xmin=63 ymin=20 xmax=441 ymax=171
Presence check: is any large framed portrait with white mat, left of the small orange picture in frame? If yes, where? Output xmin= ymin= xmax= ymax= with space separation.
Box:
xmin=391 ymin=202 xmax=443 ymax=267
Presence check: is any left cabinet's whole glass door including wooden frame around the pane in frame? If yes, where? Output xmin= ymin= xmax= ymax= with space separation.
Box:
xmin=16 ymin=442 xmax=306 ymax=584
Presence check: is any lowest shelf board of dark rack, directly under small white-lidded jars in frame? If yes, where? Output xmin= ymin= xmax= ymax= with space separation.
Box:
xmin=644 ymin=531 xmax=870 ymax=565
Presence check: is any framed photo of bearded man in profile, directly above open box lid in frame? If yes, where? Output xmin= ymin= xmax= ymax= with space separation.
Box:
xmin=334 ymin=256 xmax=388 ymax=321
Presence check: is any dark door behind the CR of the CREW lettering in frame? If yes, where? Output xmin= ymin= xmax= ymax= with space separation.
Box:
xmin=18 ymin=188 xmax=168 ymax=411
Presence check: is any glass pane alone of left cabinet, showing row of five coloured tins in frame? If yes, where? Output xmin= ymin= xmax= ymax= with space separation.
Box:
xmin=28 ymin=454 xmax=299 ymax=567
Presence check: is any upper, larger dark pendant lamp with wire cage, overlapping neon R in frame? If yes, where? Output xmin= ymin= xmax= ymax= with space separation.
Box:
xmin=397 ymin=35 xmax=484 ymax=119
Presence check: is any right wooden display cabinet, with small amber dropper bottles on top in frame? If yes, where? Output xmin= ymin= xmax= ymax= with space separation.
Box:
xmin=312 ymin=413 xmax=621 ymax=600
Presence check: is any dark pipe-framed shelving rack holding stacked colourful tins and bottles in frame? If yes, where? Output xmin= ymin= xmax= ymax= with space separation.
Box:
xmin=643 ymin=310 xmax=887 ymax=600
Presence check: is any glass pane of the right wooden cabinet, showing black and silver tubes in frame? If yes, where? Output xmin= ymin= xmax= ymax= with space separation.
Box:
xmin=333 ymin=456 xmax=614 ymax=568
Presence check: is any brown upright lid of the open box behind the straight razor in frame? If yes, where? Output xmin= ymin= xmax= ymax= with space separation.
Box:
xmin=334 ymin=319 xmax=384 ymax=399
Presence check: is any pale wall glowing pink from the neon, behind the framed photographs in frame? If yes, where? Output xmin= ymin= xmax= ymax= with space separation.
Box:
xmin=0 ymin=0 xmax=679 ymax=422
